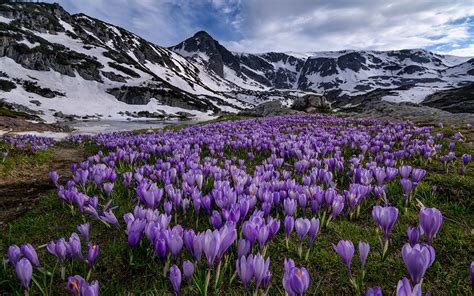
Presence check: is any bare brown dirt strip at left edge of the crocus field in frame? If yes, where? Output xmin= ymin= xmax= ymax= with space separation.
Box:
xmin=0 ymin=146 xmax=84 ymax=228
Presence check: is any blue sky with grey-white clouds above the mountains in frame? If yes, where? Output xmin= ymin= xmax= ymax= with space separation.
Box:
xmin=45 ymin=0 xmax=474 ymax=56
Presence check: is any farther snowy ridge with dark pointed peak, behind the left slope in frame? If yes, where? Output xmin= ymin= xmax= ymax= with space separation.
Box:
xmin=171 ymin=32 xmax=474 ymax=103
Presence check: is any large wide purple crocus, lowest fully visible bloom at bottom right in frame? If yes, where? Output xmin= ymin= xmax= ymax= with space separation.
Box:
xmin=402 ymin=243 xmax=435 ymax=284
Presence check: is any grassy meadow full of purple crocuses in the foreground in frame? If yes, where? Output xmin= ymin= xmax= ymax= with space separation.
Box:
xmin=0 ymin=115 xmax=474 ymax=295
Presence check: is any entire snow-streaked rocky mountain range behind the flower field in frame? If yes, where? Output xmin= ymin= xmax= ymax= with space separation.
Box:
xmin=0 ymin=3 xmax=474 ymax=122
